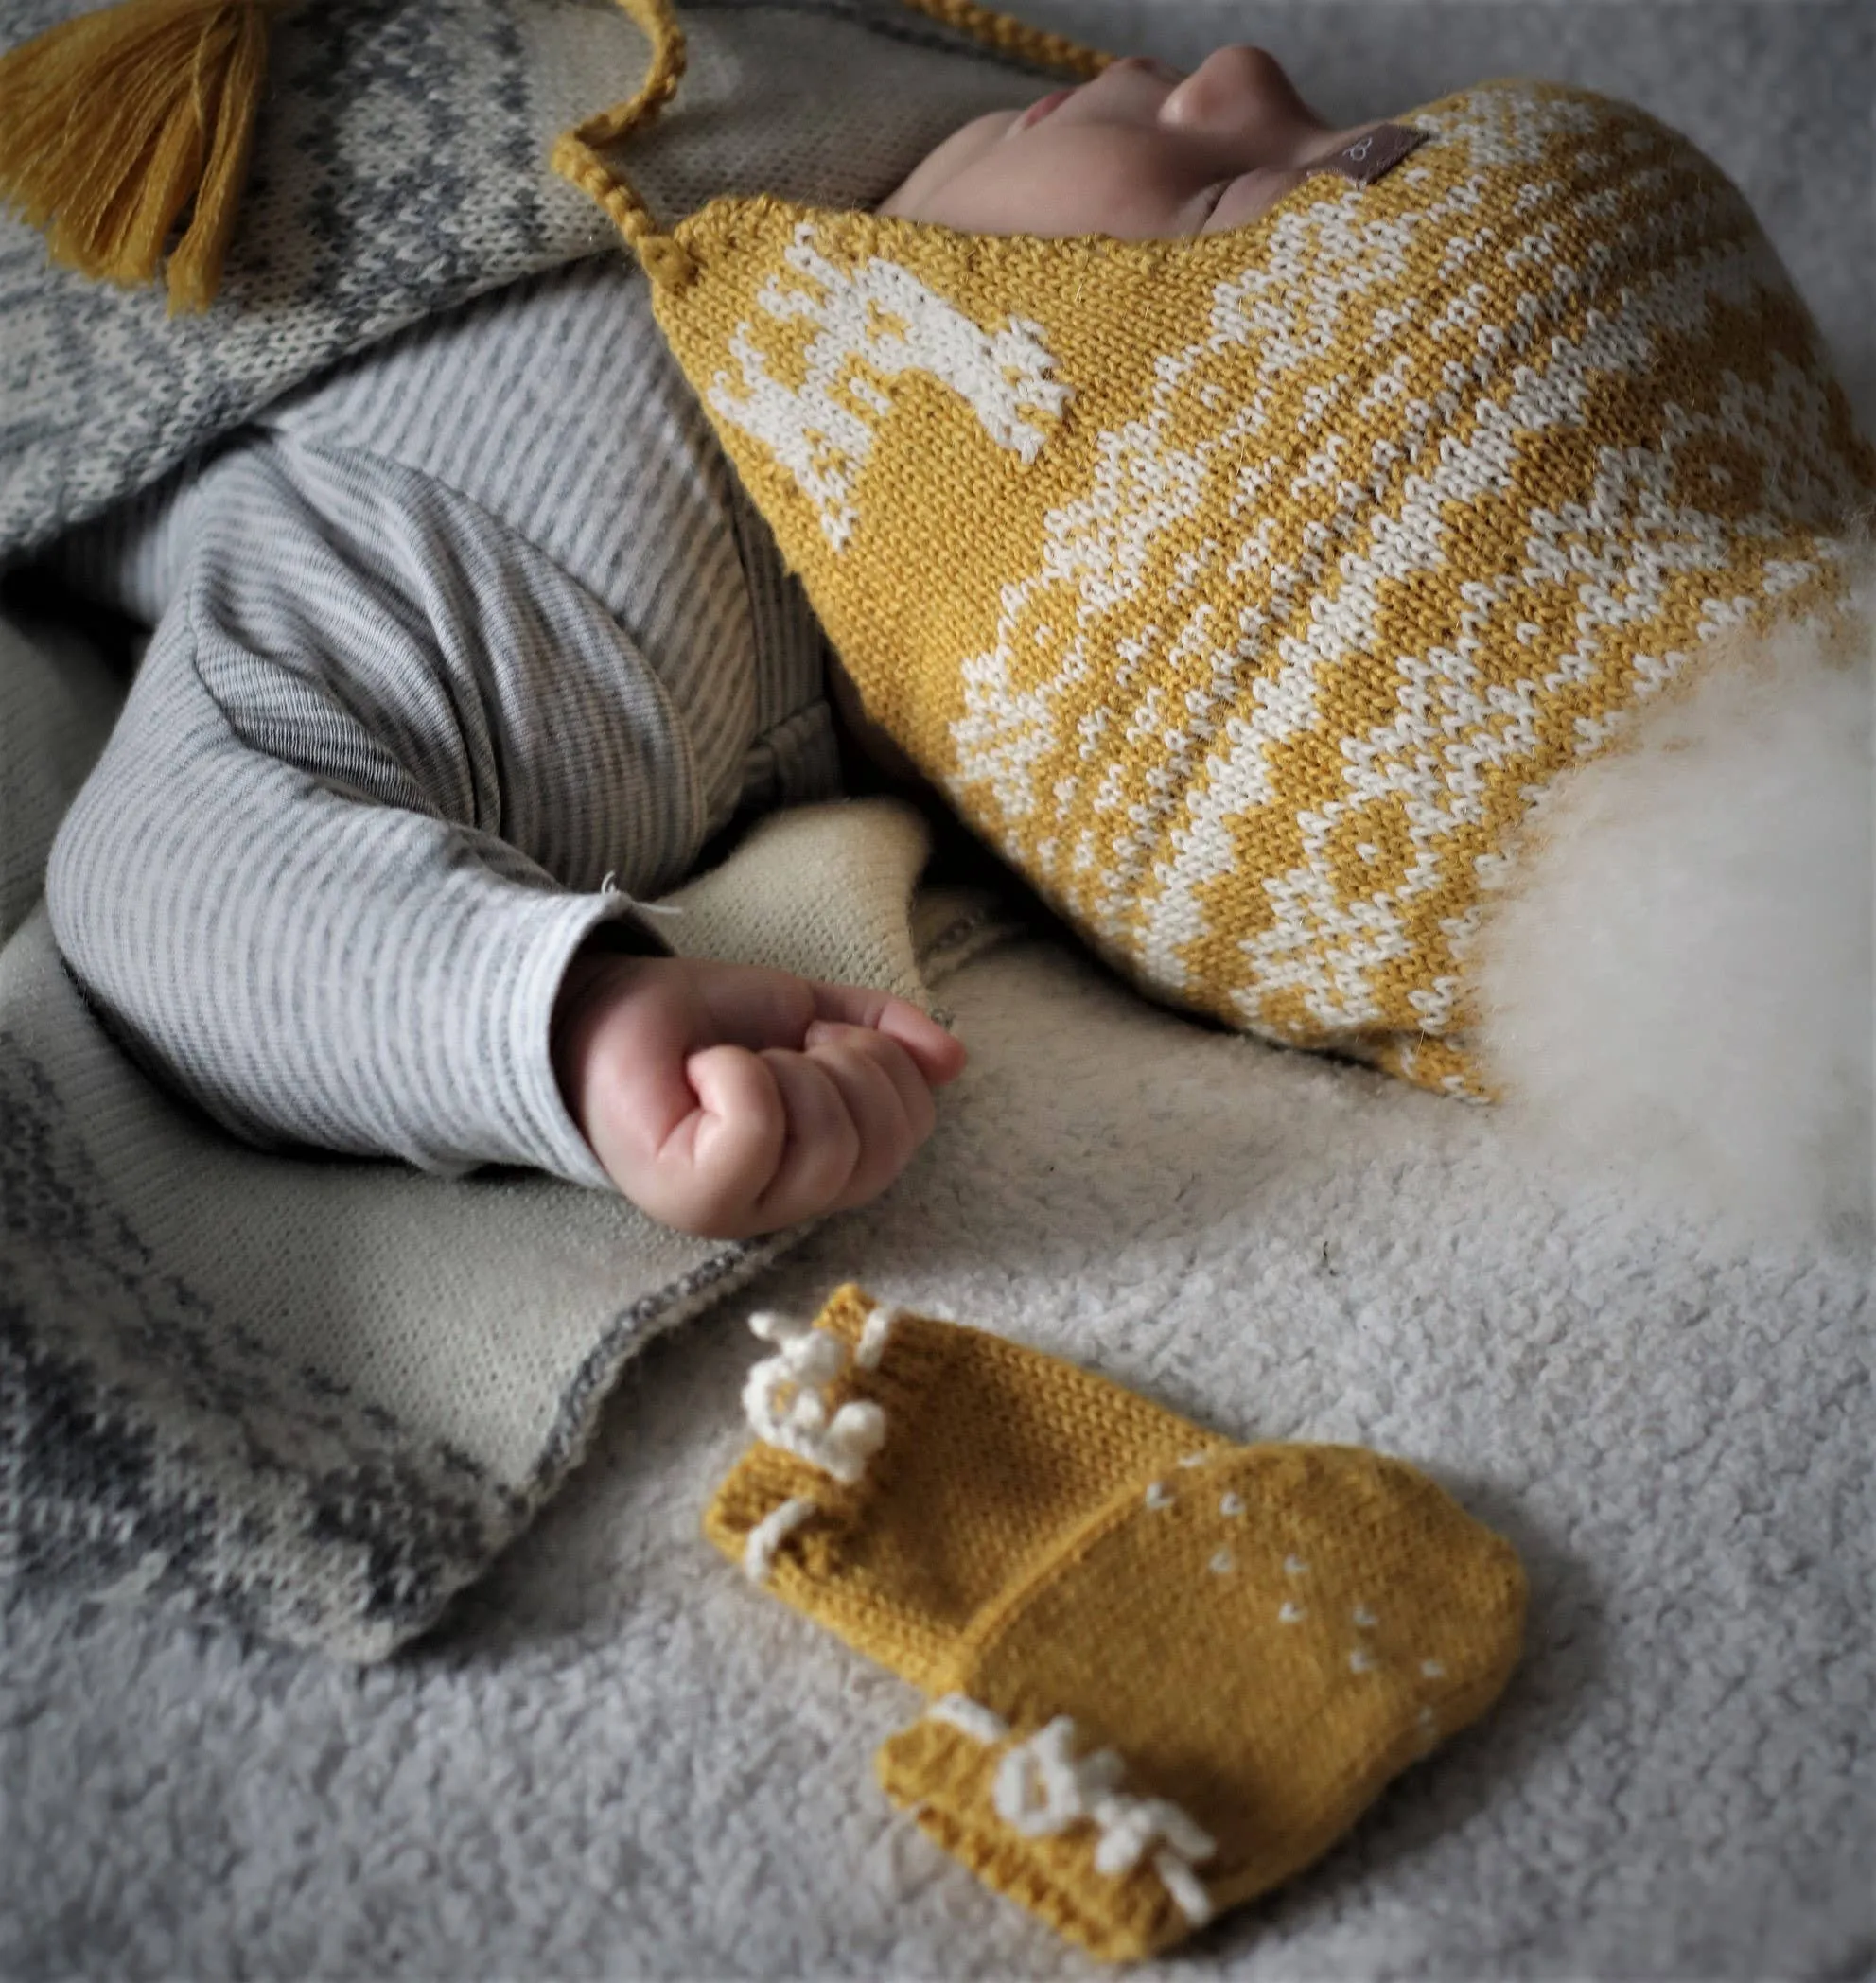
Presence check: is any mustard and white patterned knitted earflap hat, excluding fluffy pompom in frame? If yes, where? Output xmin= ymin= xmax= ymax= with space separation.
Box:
xmin=565 ymin=0 xmax=1876 ymax=1093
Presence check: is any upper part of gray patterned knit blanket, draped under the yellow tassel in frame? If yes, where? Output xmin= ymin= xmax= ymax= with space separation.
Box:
xmin=0 ymin=0 xmax=1070 ymax=561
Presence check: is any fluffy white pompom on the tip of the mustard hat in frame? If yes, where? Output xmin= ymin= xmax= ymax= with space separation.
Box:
xmin=1478 ymin=559 xmax=1876 ymax=1236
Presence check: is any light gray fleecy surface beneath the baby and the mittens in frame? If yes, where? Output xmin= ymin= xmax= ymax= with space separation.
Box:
xmin=0 ymin=0 xmax=1876 ymax=1983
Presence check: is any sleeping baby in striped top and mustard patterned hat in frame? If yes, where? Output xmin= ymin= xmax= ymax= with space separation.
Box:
xmin=36 ymin=26 xmax=1876 ymax=1236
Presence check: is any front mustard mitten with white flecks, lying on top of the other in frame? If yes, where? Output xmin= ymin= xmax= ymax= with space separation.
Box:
xmin=879 ymin=1446 xmax=1525 ymax=1959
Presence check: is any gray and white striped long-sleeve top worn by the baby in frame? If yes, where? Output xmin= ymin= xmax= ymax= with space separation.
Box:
xmin=47 ymin=255 xmax=837 ymax=1185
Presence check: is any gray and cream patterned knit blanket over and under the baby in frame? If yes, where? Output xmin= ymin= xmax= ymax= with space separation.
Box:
xmin=0 ymin=0 xmax=1037 ymax=1659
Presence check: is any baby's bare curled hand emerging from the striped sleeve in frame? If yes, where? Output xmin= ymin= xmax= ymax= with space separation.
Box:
xmin=553 ymin=952 xmax=964 ymax=1239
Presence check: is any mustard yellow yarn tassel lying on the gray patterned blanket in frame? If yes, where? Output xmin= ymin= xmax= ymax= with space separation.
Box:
xmin=0 ymin=0 xmax=273 ymax=315
